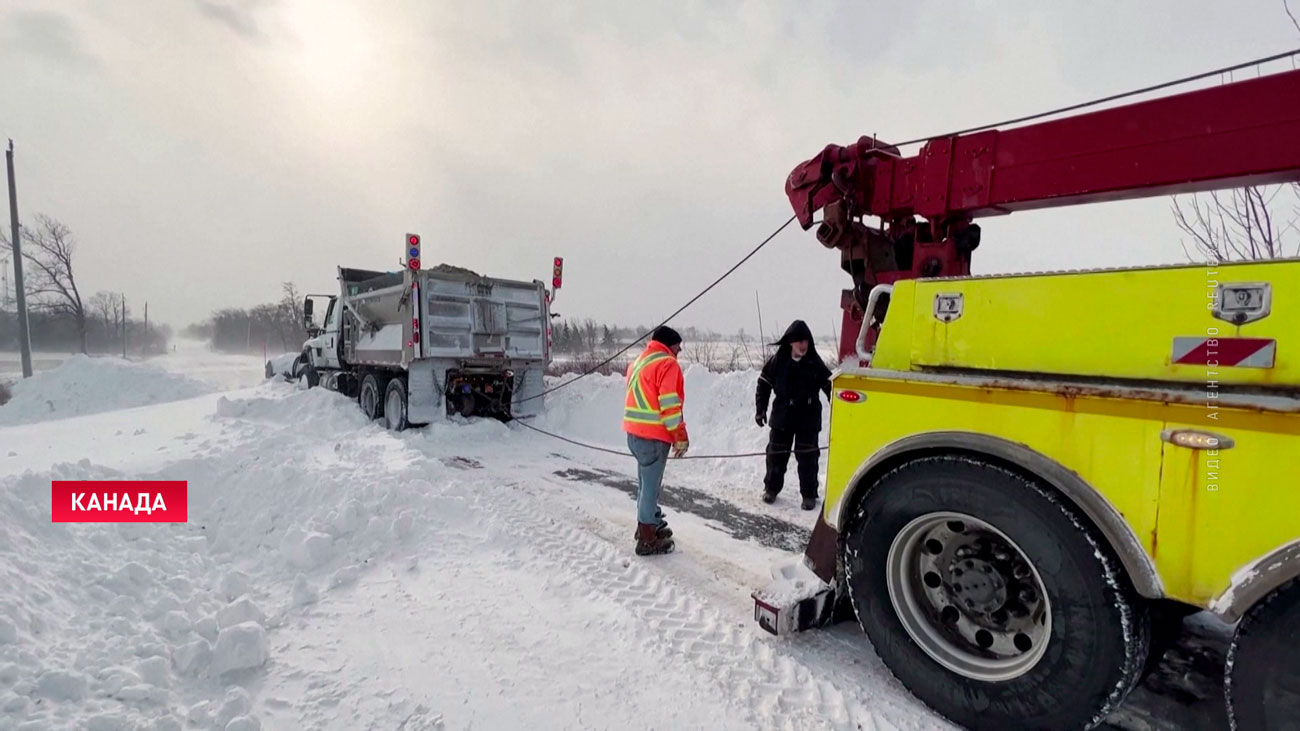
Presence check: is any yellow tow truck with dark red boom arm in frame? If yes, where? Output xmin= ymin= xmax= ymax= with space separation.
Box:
xmin=754 ymin=65 xmax=1300 ymax=731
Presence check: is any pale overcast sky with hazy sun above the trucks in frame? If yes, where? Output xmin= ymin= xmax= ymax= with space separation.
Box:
xmin=0 ymin=0 xmax=1300 ymax=336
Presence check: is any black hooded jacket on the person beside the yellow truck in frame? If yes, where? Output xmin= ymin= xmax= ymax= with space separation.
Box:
xmin=757 ymin=320 xmax=831 ymax=432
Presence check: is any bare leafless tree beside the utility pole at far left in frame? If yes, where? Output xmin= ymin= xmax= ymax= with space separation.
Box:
xmin=0 ymin=213 xmax=86 ymax=352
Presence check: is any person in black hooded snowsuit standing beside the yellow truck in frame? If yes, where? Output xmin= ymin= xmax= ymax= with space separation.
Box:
xmin=754 ymin=320 xmax=831 ymax=510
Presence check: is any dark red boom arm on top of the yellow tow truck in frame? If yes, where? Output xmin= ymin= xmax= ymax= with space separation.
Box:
xmin=785 ymin=70 xmax=1300 ymax=356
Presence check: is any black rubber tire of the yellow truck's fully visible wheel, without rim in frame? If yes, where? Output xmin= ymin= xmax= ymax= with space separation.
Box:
xmin=844 ymin=455 xmax=1151 ymax=731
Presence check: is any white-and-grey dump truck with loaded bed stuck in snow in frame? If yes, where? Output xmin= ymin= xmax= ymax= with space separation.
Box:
xmin=296 ymin=234 xmax=562 ymax=431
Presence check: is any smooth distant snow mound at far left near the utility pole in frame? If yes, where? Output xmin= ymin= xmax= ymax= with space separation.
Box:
xmin=0 ymin=355 xmax=212 ymax=427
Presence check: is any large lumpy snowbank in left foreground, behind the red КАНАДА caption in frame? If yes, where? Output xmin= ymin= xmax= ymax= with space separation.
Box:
xmin=0 ymin=385 xmax=488 ymax=730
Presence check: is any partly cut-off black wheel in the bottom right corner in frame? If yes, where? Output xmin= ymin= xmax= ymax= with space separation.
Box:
xmin=1223 ymin=579 xmax=1300 ymax=731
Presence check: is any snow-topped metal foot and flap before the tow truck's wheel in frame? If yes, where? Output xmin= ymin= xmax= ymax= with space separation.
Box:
xmin=750 ymin=509 xmax=837 ymax=636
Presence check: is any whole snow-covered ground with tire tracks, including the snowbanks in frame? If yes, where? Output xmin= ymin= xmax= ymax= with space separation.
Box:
xmin=0 ymin=346 xmax=1216 ymax=731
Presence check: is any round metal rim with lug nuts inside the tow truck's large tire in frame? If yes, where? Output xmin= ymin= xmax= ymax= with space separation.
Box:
xmin=885 ymin=512 xmax=1052 ymax=683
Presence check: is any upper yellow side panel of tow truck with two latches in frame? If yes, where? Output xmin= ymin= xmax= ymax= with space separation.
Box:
xmin=872 ymin=261 xmax=1300 ymax=386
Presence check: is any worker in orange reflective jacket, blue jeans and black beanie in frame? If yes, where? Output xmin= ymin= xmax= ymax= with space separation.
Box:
xmin=623 ymin=326 xmax=690 ymax=555
